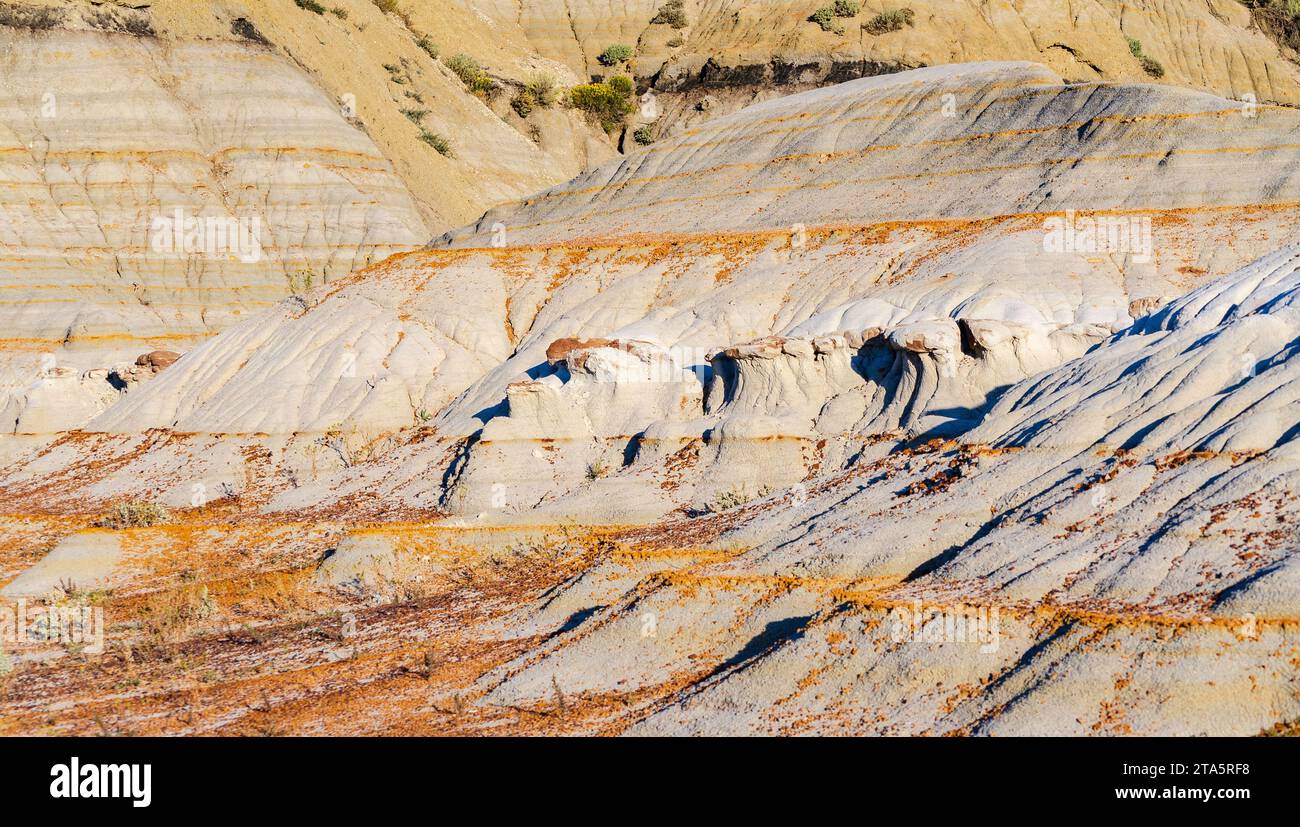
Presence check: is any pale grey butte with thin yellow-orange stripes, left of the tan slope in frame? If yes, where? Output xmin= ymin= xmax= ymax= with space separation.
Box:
xmin=0 ymin=25 xmax=425 ymax=433
